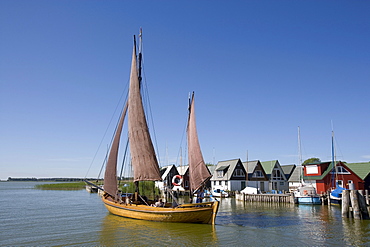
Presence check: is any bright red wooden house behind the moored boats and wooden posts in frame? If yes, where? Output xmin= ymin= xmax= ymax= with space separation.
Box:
xmin=303 ymin=161 xmax=365 ymax=194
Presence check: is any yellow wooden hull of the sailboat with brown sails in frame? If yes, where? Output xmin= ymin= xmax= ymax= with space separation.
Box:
xmin=102 ymin=196 xmax=219 ymax=224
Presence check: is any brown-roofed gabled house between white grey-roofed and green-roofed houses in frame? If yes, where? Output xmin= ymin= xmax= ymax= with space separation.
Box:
xmin=242 ymin=160 xmax=269 ymax=193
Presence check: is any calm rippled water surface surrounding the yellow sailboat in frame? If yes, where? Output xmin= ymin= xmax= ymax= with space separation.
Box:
xmin=0 ymin=182 xmax=370 ymax=246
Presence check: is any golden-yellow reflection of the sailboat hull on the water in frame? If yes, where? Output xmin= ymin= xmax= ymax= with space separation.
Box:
xmin=99 ymin=214 xmax=218 ymax=246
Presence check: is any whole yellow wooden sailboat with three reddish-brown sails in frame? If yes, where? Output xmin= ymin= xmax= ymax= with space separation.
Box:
xmin=102 ymin=30 xmax=219 ymax=224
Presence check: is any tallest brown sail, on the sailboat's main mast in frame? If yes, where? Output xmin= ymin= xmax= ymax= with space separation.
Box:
xmin=128 ymin=44 xmax=161 ymax=182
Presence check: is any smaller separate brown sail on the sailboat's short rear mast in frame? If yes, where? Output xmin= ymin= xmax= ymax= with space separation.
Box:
xmin=187 ymin=93 xmax=212 ymax=193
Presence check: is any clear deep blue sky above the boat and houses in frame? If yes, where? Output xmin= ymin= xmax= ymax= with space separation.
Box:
xmin=0 ymin=0 xmax=370 ymax=180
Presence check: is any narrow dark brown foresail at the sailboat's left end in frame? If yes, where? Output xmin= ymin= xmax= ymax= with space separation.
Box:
xmin=104 ymin=103 xmax=127 ymax=197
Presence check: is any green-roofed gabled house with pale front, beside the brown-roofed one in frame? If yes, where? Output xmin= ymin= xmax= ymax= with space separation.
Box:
xmin=261 ymin=160 xmax=289 ymax=192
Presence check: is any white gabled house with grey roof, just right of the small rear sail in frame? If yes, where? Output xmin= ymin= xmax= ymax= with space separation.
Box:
xmin=211 ymin=159 xmax=246 ymax=191
